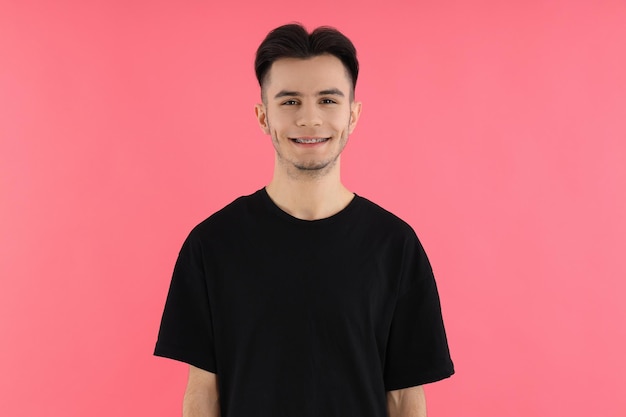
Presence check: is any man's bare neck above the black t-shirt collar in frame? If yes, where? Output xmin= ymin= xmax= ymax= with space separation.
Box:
xmin=265 ymin=161 xmax=354 ymax=220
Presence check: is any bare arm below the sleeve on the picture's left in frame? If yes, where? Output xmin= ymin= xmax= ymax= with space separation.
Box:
xmin=183 ymin=365 xmax=220 ymax=417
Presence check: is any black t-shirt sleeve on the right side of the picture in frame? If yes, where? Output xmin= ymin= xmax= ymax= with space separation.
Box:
xmin=384 ymin=237 xmax=454 ymax=391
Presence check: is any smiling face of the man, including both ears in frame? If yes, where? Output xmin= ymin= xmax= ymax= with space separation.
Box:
xmin=255 ymin=55 xmax=361 ymax=177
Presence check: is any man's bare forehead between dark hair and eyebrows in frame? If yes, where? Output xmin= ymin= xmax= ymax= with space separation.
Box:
xmin=265 ymin=55 xmax=351 ymax=91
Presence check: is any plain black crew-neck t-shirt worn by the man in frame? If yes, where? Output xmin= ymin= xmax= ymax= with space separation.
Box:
xmin=155 ymin=189 xmax=454 ymax=417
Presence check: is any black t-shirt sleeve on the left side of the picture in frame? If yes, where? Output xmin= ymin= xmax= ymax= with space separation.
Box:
xmin=154 ymin=232 xmax=217 ymax=373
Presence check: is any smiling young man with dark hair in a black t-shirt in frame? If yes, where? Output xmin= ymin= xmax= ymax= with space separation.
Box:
xmin=155 ymin=25 xmax=454 ymax=417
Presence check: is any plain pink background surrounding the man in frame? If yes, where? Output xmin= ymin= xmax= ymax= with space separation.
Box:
xmin=0 ymin=0 xmax=626 ymax=417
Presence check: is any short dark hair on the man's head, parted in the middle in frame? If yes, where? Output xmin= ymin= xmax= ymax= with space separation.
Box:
xmin=254 ymin=23 xmax=359 ymax=98
